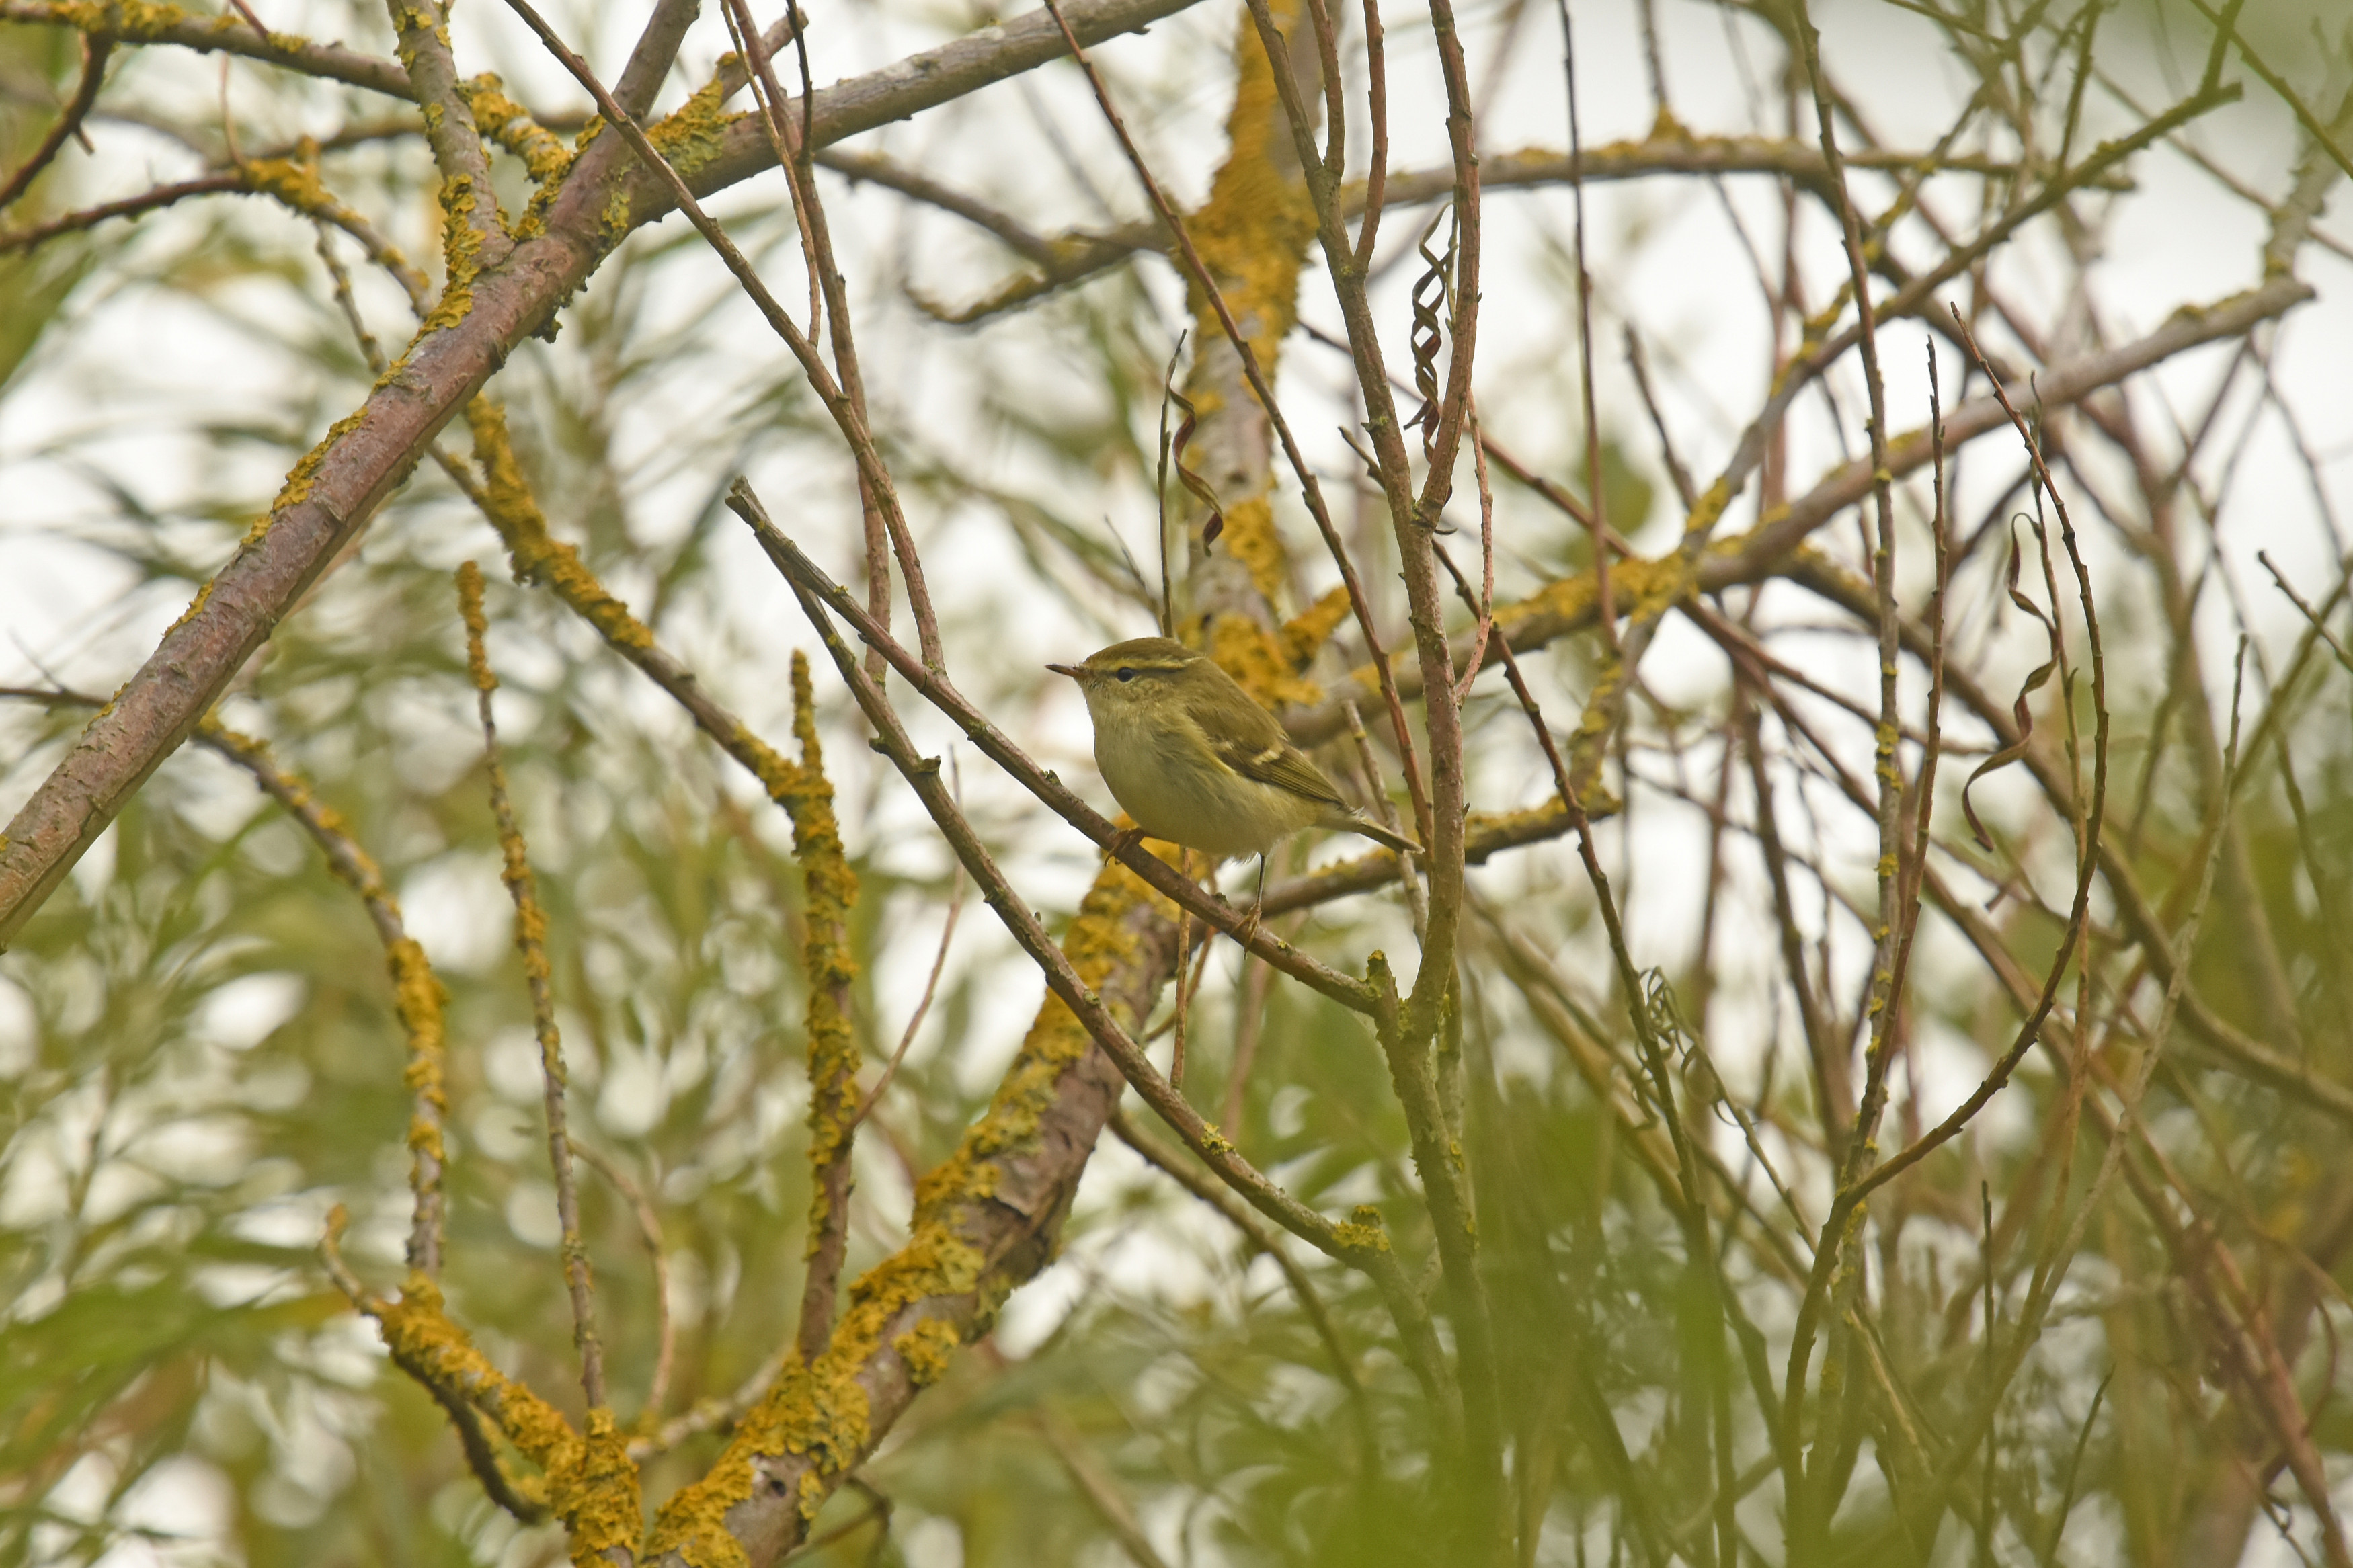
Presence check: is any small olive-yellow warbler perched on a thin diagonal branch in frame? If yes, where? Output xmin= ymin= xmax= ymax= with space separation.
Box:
xmin=1047 ymin=637 xmax=1421 ymax=882
